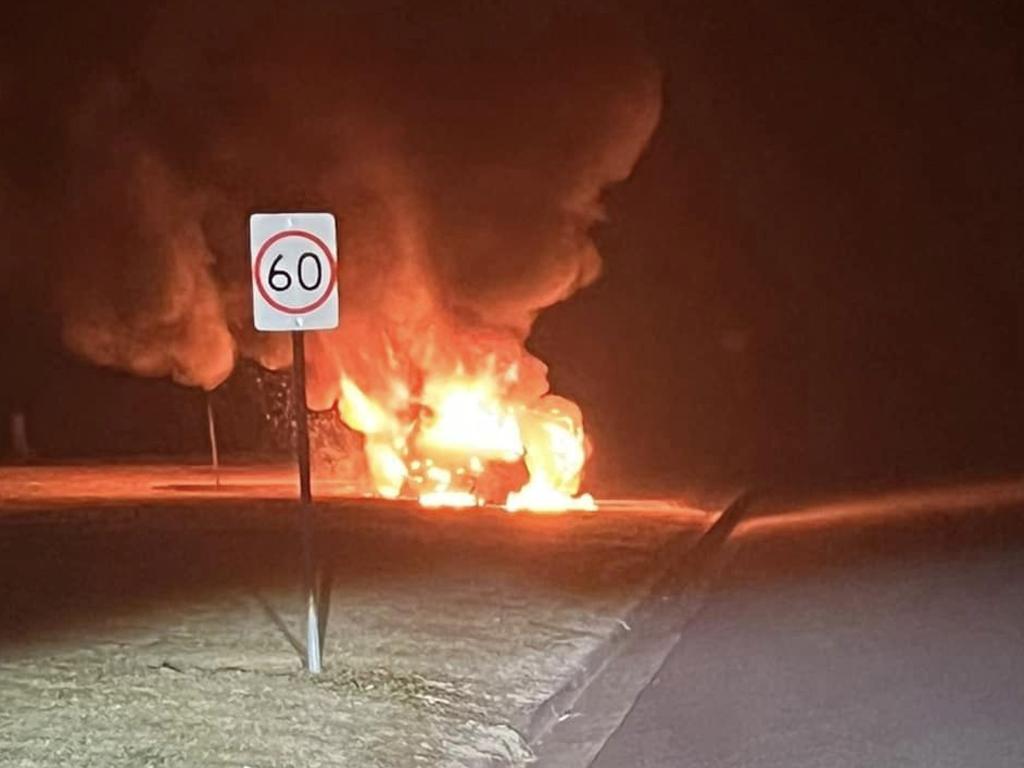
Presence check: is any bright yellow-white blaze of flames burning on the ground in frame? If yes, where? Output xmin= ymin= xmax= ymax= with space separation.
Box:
xmin=338 ymin=340 xmax=597 ymax=512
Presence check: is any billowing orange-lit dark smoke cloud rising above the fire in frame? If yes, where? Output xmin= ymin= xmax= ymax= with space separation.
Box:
xmin=37 ymin=2 xmax=660 ymax=397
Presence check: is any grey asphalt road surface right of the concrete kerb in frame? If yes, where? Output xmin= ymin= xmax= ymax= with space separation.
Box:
xmin=593 ymin=487 xmax=1024 ymax=768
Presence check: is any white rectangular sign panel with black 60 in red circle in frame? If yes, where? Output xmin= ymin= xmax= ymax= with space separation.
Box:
xmin=249 ymin=213 xmax=338 ymax=331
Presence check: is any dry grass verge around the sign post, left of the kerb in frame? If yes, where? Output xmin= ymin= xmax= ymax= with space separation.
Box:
xmin=0 ymin=469 xmax=712 ymax=768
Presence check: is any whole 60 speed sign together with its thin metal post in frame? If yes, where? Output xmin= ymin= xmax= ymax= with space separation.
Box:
xmin=249 ymin=213 xmax=339 ymax=674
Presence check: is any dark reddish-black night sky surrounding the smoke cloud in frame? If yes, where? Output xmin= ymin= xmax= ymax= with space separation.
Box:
xmin=0 ymin=2 xmax=1024 ymax=488
